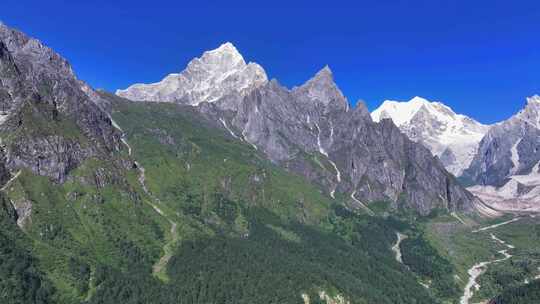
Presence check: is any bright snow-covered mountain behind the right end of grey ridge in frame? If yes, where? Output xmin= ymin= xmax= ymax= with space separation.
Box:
xmin=371 ymin=97 xmax=490 ymax=176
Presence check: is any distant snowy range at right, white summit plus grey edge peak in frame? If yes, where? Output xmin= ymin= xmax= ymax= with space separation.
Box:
xmin=371 ymin=96 xmax=540 ymax=211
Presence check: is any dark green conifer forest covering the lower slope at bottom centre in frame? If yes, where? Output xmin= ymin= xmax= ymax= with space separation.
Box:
xmin=87 ymin=209 xmax=433 ymax=303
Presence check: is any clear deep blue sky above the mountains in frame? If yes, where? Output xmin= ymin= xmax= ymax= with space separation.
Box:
xmin=0 ymin=0 xmax=540 ymax=123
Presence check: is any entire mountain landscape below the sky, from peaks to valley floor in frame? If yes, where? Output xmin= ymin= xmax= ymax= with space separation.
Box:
xmin=0 ymin=24 xmax=540 ymax=304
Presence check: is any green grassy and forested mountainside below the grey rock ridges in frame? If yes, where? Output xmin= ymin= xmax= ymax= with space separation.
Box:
xmin=0 ymin=95 xmax=464 ymax=304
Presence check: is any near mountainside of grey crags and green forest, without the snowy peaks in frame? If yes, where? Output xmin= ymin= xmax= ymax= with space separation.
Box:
xmin=0 ymin=25 xmax=528 ymax=304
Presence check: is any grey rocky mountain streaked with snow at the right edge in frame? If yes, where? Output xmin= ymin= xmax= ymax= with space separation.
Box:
xmin=464 ymin=95 xmax=540 ymax=211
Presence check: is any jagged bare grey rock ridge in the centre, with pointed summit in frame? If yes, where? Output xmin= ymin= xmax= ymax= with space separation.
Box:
xmin=118 ymin=44 xmax=477 ymax=214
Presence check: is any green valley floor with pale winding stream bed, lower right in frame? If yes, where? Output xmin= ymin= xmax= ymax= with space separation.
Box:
xmin=425 ymin=216 xmax=540 ymax=304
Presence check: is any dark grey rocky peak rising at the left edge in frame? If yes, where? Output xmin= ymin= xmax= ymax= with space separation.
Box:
xmin=0 ymin=25 xmax=120 ymax=182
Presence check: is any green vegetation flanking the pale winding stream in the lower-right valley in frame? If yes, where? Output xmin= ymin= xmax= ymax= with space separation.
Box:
xmin=420 ymin=215 xmax=540 ymax=303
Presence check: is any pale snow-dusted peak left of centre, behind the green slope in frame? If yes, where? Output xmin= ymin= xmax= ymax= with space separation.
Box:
xmin=116 ymin=42 xmax=268 ymax=107
